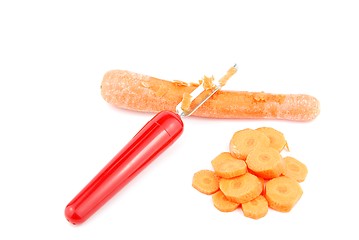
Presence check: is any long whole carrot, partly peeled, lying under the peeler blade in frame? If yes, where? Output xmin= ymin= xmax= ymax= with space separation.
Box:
xmin=101 ymin=70 xmax=320 ymax=121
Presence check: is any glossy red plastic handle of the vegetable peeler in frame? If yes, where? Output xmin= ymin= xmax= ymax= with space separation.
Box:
xmin=65 ymin=111 xmax=183 ymax=224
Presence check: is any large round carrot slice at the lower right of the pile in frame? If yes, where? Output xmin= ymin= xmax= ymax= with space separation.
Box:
xmin=265 ymin=176 xmax=303 ymax=212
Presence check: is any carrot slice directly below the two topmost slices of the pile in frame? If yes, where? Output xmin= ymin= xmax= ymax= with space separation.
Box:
xmin=246 ymin=147 xmax=284 ymax=179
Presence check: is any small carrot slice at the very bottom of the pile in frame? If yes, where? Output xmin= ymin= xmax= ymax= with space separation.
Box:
xmin=242 ymin=195 xmax=268 ymax=219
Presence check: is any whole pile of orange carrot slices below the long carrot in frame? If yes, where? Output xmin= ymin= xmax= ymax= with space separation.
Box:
xmin=192 ymin=127 xmax=308 ymax=219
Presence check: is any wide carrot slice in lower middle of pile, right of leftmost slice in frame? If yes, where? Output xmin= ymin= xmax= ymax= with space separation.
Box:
xmin=219 ymin=173 xmax=262 ymax=203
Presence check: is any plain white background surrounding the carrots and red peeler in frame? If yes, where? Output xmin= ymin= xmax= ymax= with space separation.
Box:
xmin=0 ymin=0 xmax=359 ymax=239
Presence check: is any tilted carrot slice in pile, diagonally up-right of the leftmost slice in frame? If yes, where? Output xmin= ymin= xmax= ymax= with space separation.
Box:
xmin=211 ymin=152 xmax=247 ymax=178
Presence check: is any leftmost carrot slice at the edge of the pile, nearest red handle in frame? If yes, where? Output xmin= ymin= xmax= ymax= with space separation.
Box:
xmin=192 ymin=170 xmax=219 ymax=195
